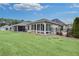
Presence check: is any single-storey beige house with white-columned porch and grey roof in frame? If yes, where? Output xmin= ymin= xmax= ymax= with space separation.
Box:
xmin=14 ymin=18 xmax=67 ymax=34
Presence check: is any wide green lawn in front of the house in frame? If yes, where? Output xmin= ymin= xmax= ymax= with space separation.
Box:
xmin=0 ymin=31 xmax=79 ymax=56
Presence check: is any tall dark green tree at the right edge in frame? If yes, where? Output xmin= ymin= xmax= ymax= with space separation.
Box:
xmin=72 ymin=17 xmax=79 ymax=38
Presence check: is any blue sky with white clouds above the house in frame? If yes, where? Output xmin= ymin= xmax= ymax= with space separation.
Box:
xmin=0 ymin=3 xmax=79 ymax=23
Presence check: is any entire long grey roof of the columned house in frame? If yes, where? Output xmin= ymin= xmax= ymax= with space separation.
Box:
xmin=16 ymin=18 xmax=66 ymax=26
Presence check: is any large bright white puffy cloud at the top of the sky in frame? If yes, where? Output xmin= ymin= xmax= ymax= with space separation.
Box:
xmin=13 ymin=3 xmax=48 ymax=10
